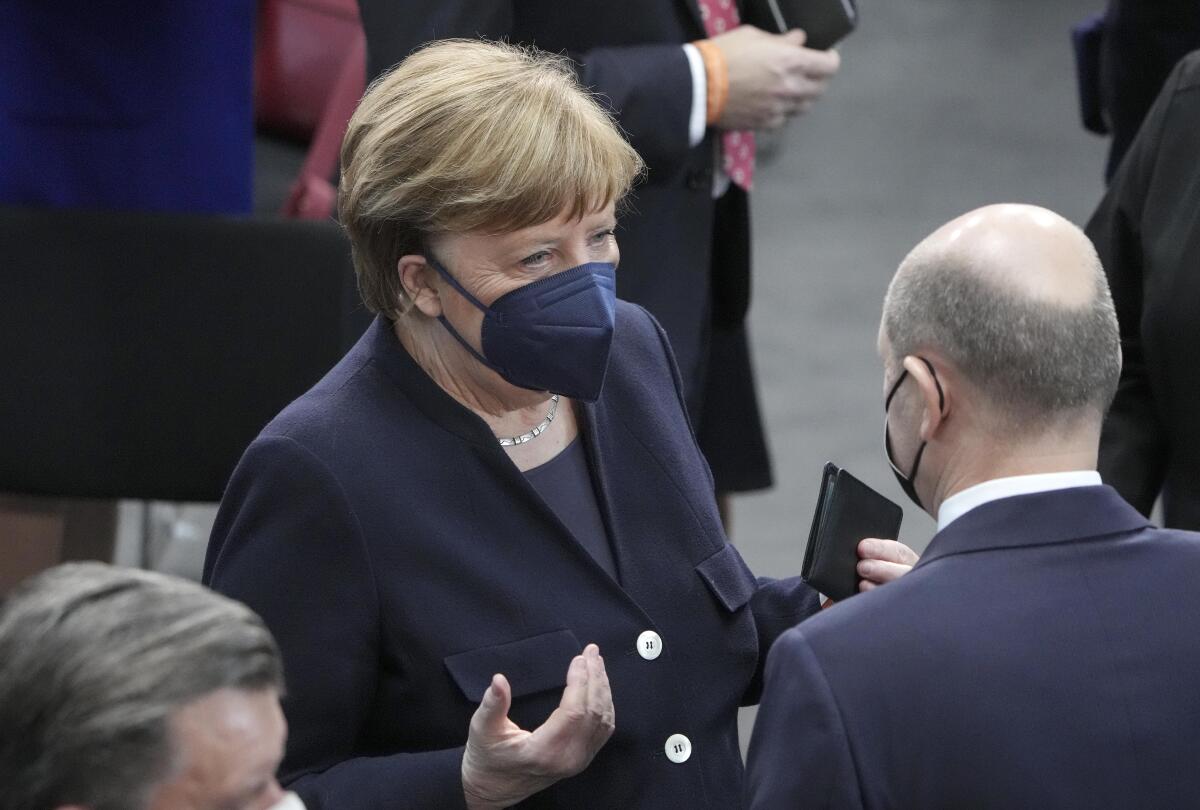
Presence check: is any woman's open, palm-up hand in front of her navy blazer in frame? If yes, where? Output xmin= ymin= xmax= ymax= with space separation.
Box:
xmin=462 ymin=644 xmax=616 ymax=810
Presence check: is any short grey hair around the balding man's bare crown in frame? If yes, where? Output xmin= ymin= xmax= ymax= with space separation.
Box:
xmin=883 ymin=243 xmax=1121 ymax=430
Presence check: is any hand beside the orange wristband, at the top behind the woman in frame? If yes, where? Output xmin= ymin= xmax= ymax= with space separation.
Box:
xmin=712 ymin=25 xmax=841 ymax=130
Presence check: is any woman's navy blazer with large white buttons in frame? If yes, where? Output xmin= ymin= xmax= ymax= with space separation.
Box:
xmin=204 ymin=302 xmax=816 ymax=810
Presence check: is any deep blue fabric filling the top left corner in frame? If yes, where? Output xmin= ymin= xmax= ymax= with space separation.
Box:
xmin=0 ymin=0 xmax=254 ymax=214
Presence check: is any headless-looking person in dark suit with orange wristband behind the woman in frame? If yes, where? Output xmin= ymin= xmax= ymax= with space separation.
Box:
xmin=359 ymin=0 xmax=840 ymax=521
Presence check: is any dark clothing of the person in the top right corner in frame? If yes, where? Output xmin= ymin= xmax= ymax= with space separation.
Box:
xmin=1100 ymin=0 xmax=1200 ymax=179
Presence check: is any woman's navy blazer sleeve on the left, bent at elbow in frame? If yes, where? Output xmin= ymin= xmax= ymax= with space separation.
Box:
xmin=204 ymin=436 xmax=466 ymax=810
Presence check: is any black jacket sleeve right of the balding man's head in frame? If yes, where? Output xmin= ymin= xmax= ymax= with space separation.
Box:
xmin=1087 ymin=58 xmax=1181 ymax=515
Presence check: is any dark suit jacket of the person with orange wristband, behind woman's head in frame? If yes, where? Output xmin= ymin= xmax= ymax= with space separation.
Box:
xmin=359 ymin=0 xmax=750 ymax=405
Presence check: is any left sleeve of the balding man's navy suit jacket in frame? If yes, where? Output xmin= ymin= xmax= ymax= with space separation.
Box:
xmin=746 ymin=630 xmax=863 ymax=810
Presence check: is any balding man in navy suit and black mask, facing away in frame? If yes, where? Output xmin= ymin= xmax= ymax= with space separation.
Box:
xmin=748 ymin=205 xmax=1200 ymax=809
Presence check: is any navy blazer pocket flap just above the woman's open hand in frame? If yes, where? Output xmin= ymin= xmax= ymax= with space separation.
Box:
xmin=445 ymin=630 xmax=583 ymax=703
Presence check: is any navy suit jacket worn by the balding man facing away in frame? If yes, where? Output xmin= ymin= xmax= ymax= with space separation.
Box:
xmin=748 ymin=486 xmax=1200 ymax=810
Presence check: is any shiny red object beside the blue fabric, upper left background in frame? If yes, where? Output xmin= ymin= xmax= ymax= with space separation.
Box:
xmin=254 ymin=0 xmax=366 ymax=220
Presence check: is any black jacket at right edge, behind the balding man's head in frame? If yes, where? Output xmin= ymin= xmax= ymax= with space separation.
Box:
xmin=1087 ymin=52 xmax=1200 ymax=529
